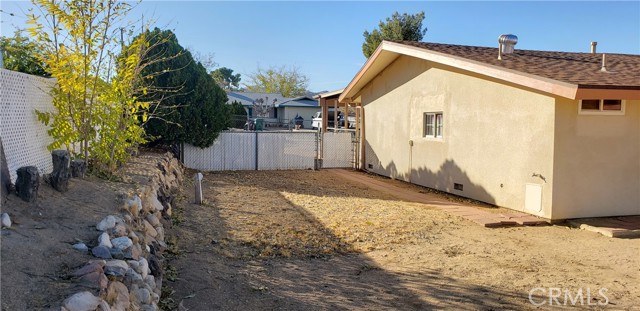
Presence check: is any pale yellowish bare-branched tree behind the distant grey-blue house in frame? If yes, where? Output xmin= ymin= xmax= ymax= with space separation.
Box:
xmin=247 ymin=66 xmax=309 ymax=97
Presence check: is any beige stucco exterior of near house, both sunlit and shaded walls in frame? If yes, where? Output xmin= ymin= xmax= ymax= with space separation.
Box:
xmin=360 ymin=56 xmax=640 ymax=219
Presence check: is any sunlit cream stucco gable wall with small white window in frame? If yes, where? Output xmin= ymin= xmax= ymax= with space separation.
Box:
xmin=361 ymin=56 xmax=555 ymax=217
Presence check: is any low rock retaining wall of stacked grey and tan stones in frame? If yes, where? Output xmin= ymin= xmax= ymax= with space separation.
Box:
xmin=62 ymin=153 xmax=184 ymax=311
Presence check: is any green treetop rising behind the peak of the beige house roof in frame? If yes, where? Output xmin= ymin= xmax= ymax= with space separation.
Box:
xmin=362 ymin=12 xmax=427 ymax=58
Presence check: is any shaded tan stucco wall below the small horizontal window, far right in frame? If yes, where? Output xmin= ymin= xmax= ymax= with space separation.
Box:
xmin=552 ymin=99 xmax=640 ymax=218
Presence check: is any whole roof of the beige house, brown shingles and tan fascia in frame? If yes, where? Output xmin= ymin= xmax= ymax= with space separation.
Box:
xmin=340 ymin=41 xmax=640 ymax=101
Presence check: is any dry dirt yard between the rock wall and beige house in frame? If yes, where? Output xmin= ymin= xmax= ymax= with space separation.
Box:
xmin=165 ymin=170 xmax=640 ymax=310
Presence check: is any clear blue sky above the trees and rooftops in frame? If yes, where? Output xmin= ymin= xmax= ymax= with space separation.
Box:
xmin=0 ymin=0 xmax=640 ymax=91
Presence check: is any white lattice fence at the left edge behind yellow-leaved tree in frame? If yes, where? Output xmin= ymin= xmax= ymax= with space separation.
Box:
xmin=0 ymin=69 xmax=54 ymax=182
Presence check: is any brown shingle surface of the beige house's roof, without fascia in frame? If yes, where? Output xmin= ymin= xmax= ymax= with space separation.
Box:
xmin=396 ymin=41 xmax=640 ymax=89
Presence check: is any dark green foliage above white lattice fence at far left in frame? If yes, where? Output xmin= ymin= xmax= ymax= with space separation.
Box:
xmin=0 ymin=29 xmax=51 ymax=77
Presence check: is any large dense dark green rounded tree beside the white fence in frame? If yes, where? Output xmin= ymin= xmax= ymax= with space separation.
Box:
xmin=139 ymin=28 xmax=230 ymax=148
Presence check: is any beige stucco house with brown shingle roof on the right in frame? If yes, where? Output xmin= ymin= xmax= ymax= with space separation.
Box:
xmin=339 ymin=41 xmax=640 ymax=219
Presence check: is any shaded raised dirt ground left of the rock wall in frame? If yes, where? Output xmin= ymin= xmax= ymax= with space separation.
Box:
xmin=0 ymin=177 xmax=131 ymax=311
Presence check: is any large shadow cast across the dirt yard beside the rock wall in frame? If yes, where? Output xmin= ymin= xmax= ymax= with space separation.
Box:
xmin=169 ymin=172 xmax=528 ymax=310
